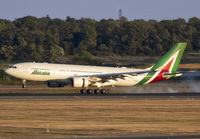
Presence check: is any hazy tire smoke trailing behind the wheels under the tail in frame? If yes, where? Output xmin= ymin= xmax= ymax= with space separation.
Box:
xmin=111 ymin=71 xmax=200 ymax=93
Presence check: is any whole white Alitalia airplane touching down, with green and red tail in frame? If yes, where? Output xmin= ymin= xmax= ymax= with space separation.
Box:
xmin=5 ymin=42 xmax=187 ymax=94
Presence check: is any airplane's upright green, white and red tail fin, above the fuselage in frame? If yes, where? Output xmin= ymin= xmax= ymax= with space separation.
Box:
xmin=151 ymin=42 xmax=187 ymax=73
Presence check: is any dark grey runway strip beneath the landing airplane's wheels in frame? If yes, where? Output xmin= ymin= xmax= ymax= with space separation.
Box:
xmin=0 ymin=92 xmax=200 ymax=99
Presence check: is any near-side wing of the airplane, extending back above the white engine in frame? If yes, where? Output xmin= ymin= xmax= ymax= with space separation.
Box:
xmin=76 ymin=70 xmax=153 ymax=83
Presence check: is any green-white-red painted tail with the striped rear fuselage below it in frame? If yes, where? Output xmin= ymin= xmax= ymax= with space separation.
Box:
xmin=136 ymin=42 xmax=187 ymax=85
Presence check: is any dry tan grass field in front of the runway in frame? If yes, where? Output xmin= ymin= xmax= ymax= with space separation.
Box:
xmin=0 ymin=98 xmax=200 ymax=138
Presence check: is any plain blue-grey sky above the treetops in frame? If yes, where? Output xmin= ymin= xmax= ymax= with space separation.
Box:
xmin=0 ymin=0 xmax=200 ymax=21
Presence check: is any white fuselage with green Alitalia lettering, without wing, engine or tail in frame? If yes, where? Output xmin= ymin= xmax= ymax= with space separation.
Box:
xmin=5 ymin=63 xmax=147 ymax=86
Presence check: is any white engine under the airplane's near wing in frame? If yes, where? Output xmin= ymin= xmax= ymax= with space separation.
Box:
xmin=71 ymin=77 xmax=90 ymax=87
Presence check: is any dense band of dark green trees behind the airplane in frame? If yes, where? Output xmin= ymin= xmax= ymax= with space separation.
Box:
xmin=0 ymin=15 xmax=200 ymax=62
